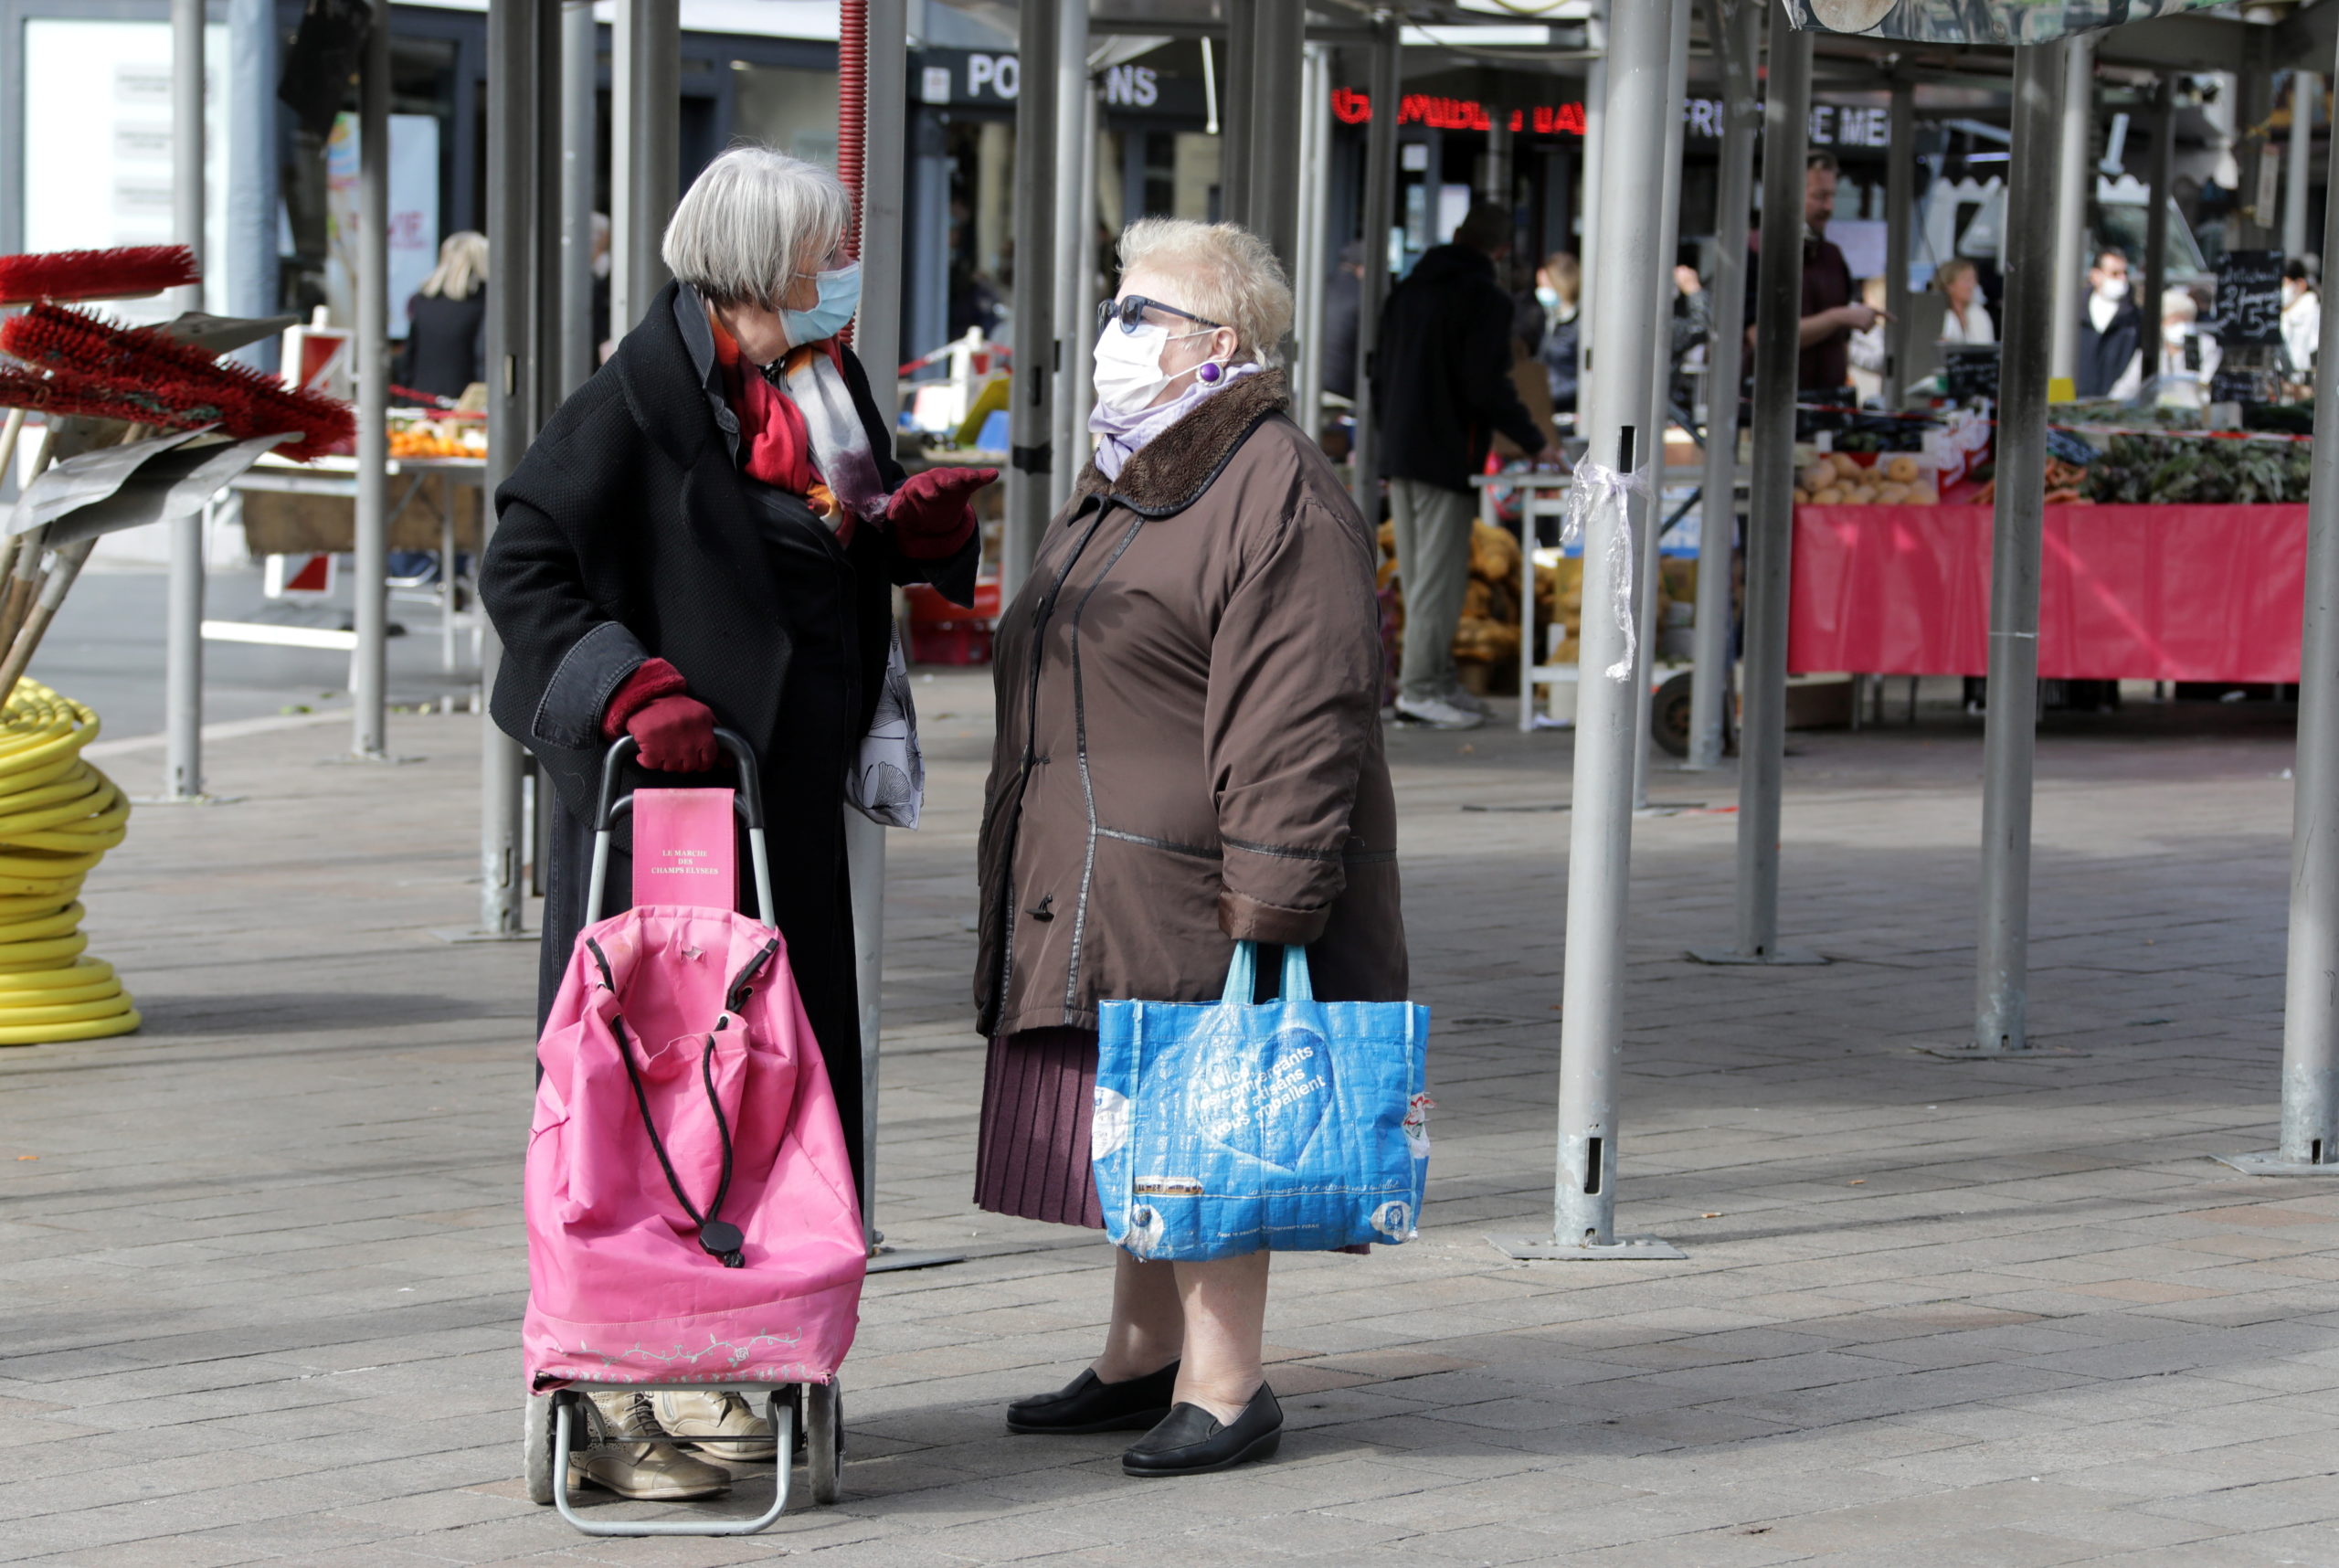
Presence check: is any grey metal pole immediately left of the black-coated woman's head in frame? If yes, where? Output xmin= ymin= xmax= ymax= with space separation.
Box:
xmin=609 ymin=0 xmax=673 ymax=337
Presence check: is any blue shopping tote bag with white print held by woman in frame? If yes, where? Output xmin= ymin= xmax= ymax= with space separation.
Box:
xmin=1090 ymin=941 xmax=1429 ymax=1259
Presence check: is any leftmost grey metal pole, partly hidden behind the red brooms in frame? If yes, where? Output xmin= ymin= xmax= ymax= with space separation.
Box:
xmin=162 ymin=0 xmax=208 ymax=800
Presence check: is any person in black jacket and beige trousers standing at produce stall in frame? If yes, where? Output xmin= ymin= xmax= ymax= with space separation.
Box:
xmin=1373 ymin=201 xmax=1561 ymax=730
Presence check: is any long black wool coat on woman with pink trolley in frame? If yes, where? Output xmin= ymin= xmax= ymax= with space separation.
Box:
xmin=480 ymin=283 xmax=978 ymax=1193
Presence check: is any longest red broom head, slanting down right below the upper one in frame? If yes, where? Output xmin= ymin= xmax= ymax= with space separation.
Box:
xmin=0 ymin=304 xmax=358 ymax=461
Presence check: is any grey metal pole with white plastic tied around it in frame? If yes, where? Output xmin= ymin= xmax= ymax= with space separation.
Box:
xmin=1495 ymin=5 xmax=1682 ymax=1259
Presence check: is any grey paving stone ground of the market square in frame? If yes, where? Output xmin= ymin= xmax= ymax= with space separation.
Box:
xmin=0 ymin=674 xmax=2339 ymax=1568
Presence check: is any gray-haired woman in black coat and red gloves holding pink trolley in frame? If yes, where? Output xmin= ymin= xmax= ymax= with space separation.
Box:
xmin=480 ymin=147 xmax=997 ymax=1498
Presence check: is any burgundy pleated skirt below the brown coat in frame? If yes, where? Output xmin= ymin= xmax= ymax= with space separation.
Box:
xmin=976 ymin=1027 xmax=1104 ymax=1231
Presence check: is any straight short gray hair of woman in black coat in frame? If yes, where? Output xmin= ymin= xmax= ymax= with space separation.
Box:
xmin=660 ymin=145 xmax=853 ymax=309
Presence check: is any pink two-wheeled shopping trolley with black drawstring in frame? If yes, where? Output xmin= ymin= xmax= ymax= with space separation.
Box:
xmin=522 ymin=730 xmax=868 ymax=1535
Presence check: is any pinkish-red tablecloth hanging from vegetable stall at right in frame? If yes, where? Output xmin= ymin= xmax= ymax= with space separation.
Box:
xmin=1787 ymin=505 xmax=2306 ymax=681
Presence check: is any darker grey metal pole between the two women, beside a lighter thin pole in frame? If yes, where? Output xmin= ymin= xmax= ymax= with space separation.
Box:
xmin=999 ymin=0 xmax=1062 ymax=604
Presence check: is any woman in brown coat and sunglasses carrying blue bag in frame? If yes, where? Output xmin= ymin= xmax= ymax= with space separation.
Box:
xmin=976 ymin=217 xmax=1406 ymax=1477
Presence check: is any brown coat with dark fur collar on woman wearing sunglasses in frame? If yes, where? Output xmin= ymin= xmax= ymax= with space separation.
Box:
xmin=976 ymin=370 xmax=1406 ymax=1034
